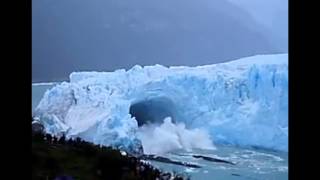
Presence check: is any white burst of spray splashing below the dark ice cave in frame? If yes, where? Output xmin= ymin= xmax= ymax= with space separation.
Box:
xmin=138 ymin=117 xmax=215 ymax=154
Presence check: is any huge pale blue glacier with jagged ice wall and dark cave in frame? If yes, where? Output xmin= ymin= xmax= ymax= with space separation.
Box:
xmin=34 ymin=54 xmax=288 ymax=153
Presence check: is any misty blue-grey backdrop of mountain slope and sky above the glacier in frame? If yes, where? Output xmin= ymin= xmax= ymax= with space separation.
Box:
xmin=32 ymin=0 xmax=287 ymax=82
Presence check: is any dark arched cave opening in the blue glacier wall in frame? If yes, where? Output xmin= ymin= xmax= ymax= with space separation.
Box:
xmin=130 ymin=97 xmax=177 ymax=127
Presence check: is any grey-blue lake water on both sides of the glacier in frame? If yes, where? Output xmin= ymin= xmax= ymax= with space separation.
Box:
xmin=32 ymin=84 xmax=288 ymax=180
